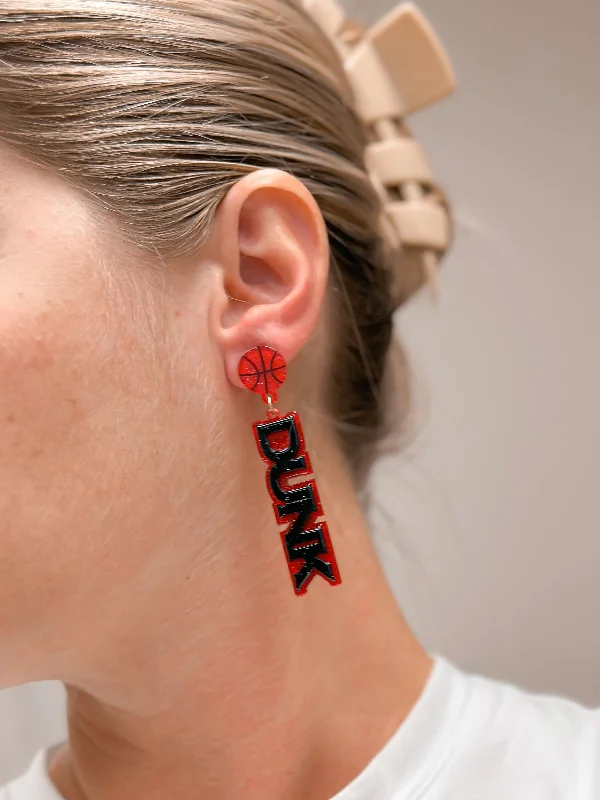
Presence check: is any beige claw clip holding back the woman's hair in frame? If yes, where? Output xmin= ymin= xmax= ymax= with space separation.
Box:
xmin=302 ymin=0 xmax=455 ymax=302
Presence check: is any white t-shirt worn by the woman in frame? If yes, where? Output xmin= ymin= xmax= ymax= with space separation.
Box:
xmin=0 ymin=655 xmax=600 ymax=800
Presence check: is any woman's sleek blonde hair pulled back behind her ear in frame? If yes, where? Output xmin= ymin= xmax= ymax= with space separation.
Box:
xmin=0 ymin=0 xmax=420 ymax=479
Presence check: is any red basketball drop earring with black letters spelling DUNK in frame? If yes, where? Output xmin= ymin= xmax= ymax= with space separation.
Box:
xmin=238 ymin=345 xmax=342 ymax=595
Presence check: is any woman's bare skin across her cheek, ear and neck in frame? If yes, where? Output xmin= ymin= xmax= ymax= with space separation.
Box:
xmin=0 ymin=147 xmax=432 ymax=800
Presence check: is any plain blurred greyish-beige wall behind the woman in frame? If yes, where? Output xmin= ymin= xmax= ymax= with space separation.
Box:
xmin=0 ymin=0 xmax=600 ymax=783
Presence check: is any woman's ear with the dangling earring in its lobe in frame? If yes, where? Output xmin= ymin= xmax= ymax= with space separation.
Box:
xmin=208 ymin=169 xmax=329 ymax=386
